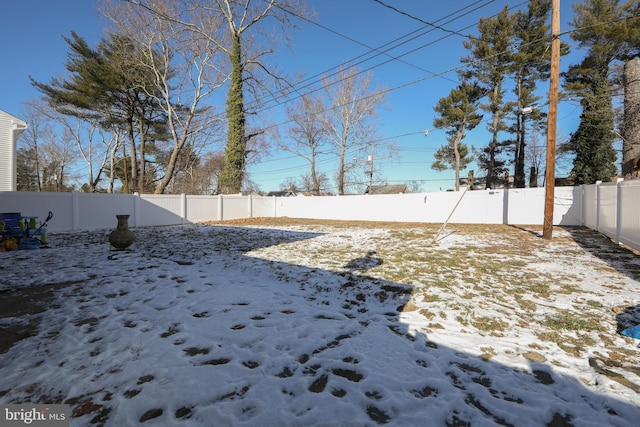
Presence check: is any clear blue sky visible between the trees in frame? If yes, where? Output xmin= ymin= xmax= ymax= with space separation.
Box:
xmin=0 ymin=0 xmax=580 ymax=191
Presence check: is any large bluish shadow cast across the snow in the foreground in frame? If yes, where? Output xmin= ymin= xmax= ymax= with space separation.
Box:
xmin=0 ymin=226 xmax=640 ymax=426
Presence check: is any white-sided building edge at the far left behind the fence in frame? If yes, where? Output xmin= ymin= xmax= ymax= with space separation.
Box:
xmin=0 ymin=110 xmax=27 ymax=191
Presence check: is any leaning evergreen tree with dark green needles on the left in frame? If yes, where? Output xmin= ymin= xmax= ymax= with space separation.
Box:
xmin=31 ymin=32 xmax=166 ymax=192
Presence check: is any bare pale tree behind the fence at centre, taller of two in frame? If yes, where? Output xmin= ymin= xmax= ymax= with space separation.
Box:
xmin=322 ymin=68 xmax=385 ymax=195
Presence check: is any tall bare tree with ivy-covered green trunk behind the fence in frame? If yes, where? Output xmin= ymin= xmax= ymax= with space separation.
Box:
xmin=122 ymin=0 xmax=307 ymax=193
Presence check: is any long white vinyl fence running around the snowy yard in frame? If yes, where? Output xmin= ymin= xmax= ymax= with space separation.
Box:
xmin=0 ymin=181 xmax=640 ymax=250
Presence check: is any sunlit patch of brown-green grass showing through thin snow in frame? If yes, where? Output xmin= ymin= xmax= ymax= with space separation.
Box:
xmin=241 ymin=219 xmax=640 ymax=374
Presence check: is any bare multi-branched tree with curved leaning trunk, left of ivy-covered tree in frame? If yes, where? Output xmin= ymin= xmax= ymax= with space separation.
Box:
xmin=103 ymin=0 xmax=226 ymax=194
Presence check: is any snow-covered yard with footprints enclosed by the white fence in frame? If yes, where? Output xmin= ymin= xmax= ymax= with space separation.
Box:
xmin=0 ymin=219 xmax=640 ymax=426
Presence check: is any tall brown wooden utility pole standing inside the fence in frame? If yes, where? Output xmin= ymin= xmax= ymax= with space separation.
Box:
xmin=542 ymin=0 xmax=560 ymax=240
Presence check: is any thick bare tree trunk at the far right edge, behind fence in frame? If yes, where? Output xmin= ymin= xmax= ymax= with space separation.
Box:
xmin=622 ymin=58 xmax=640 ymax=179
